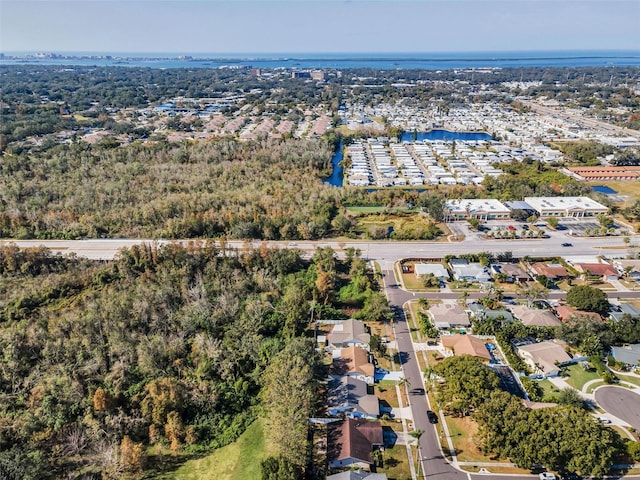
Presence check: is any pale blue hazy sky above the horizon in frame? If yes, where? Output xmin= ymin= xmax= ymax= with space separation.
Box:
xmin=0 ymin=0 xmax=640 ymax=54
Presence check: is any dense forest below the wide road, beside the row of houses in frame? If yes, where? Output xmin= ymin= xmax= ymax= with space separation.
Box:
xmin=0 ymin=246 xmax=380 ymax=480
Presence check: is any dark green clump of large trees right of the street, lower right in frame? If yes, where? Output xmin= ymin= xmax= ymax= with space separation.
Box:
xmin=433 ymin=355 xmax=623 ymax=476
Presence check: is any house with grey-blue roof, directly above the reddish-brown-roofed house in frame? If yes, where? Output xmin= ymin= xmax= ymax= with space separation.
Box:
xmin=327 ymin=375 xmax=380 ymax=419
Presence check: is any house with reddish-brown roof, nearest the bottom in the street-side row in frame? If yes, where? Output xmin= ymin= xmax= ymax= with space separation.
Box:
xmin=328 ymin=418 xmax=384 ymax=470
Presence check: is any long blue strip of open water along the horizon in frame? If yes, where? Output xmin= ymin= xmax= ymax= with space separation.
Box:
xmin=0 ymin=50 xmax=640 ymax=70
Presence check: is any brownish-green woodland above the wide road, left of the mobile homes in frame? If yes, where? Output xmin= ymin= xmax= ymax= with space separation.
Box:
xmin=0 ymin=140 xmax=349 ymax=239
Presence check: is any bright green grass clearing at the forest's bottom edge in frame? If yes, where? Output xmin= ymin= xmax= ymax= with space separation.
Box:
xmin=167 ymin=419 xmax=268 ymax=480
